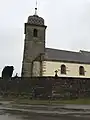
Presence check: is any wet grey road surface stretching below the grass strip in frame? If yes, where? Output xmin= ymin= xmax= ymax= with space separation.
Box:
xmin=0 ymin=102 xmax=90 ymax=120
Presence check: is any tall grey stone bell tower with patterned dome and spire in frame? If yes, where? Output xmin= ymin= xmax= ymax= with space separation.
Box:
xmin=21 ymin=7 xmax=46 ymax=77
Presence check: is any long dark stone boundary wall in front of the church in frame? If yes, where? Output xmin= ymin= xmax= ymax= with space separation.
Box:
xmin=0 ymin=77 xmax=90 ymax=99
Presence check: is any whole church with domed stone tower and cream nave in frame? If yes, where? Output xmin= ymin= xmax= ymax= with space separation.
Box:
xmin=21 ymin=8 xmax=90 ymax=78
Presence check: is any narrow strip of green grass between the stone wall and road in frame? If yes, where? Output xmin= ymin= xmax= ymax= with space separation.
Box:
xmin=12 ymin=98 xmax=90 ymax=105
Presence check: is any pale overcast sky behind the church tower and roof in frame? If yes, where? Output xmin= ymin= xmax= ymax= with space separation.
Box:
xmin=0 ymin=0 xmax=90 ymax=76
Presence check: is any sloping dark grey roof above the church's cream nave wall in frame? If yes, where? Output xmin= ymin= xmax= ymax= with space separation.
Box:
xmin=45 ymin=48 xmax=90 ymax=64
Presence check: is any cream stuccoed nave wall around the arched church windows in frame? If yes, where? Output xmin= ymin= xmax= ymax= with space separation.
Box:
xmin=43 ymin=61 xmax=90 ymax=77
